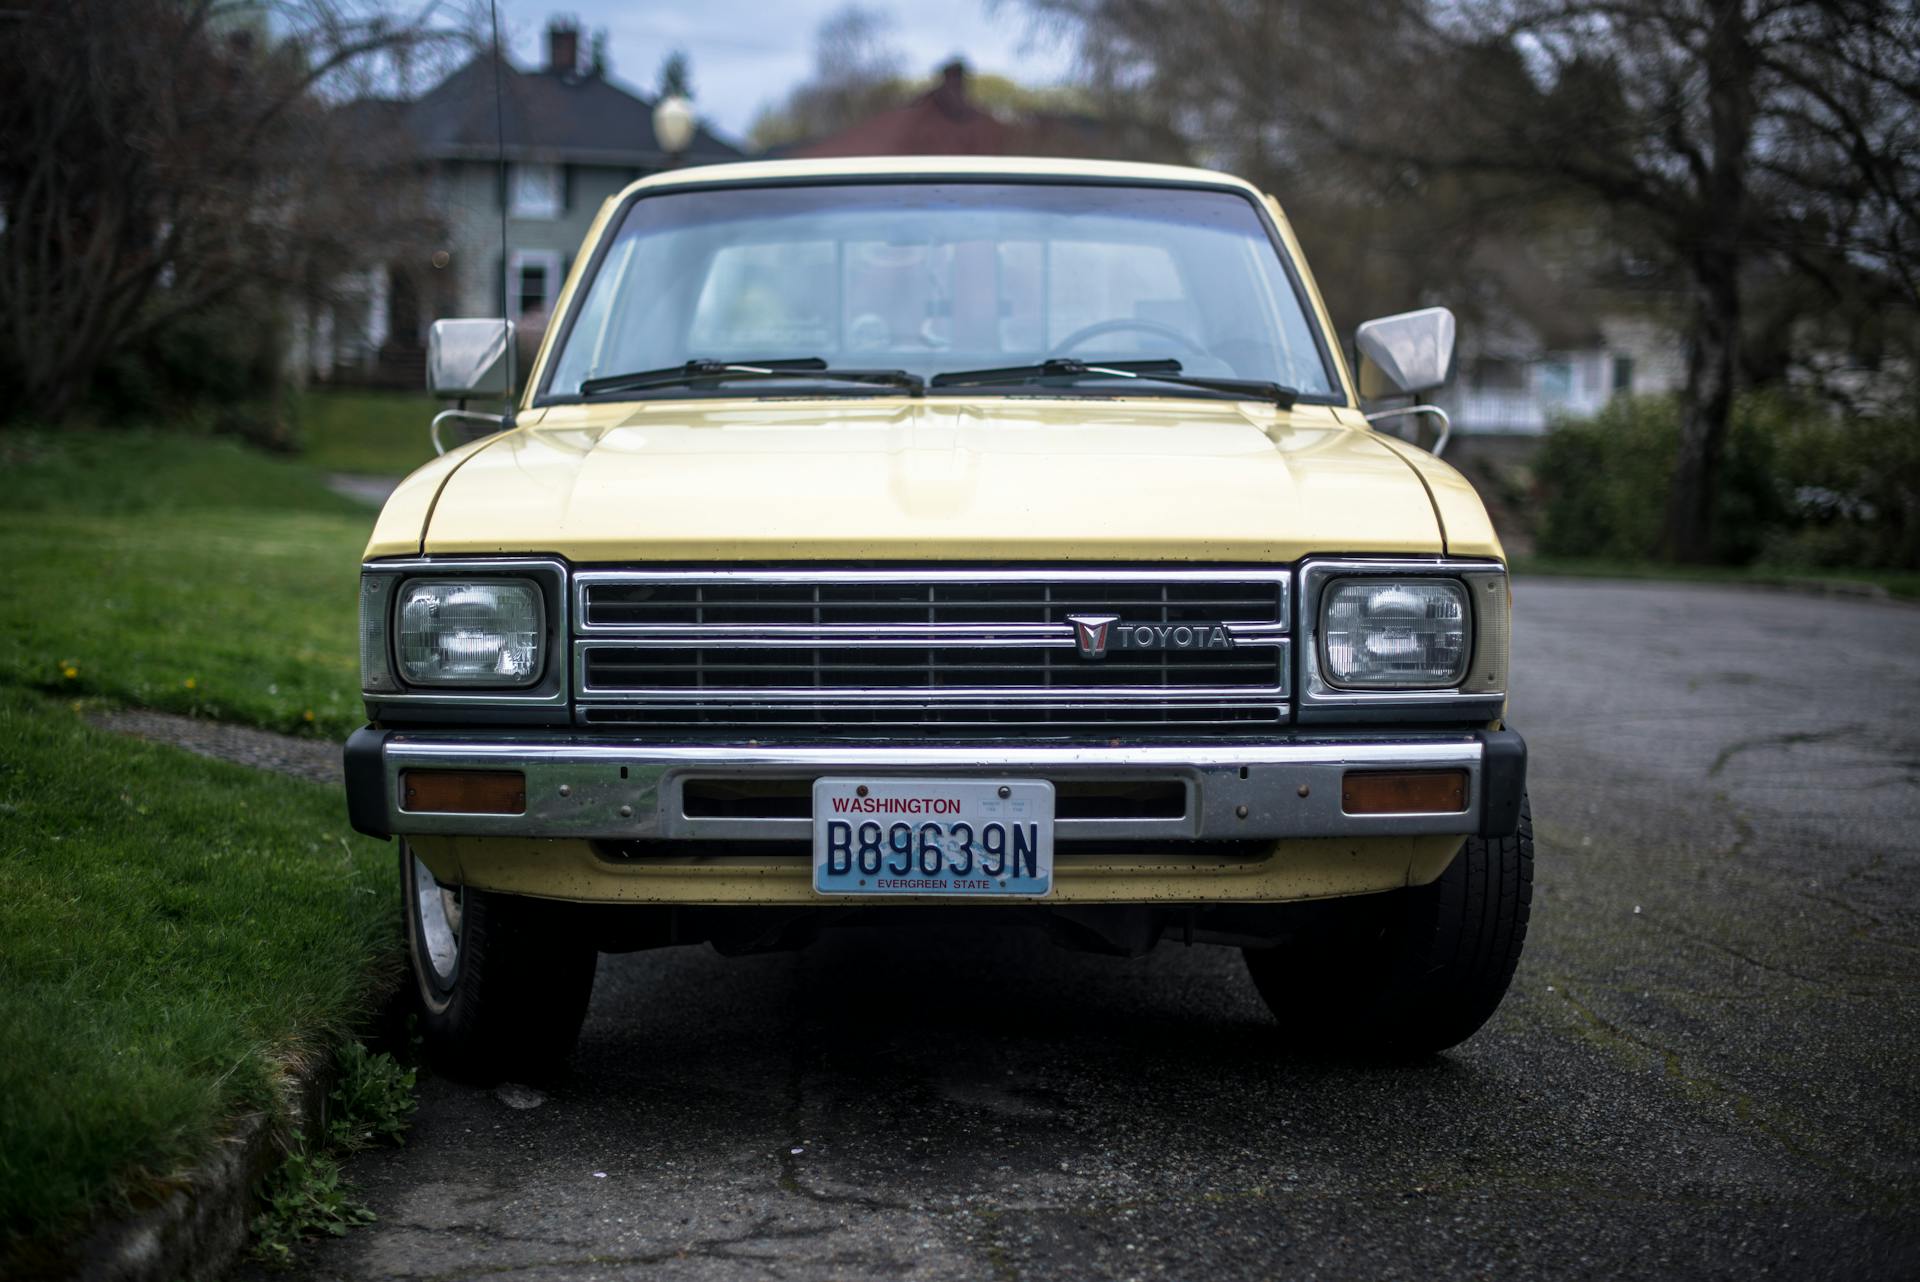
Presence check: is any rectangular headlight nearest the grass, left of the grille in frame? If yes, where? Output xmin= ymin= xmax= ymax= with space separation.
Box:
xmin=394 ymin=580 xmax=545 ymax=687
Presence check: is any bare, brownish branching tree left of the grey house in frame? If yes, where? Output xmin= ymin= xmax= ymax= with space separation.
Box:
xmin=0 ymin=0 xmax=453 ymax=418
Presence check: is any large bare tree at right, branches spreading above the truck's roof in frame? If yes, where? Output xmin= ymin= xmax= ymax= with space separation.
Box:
xmin=1027 ymin=0 xmax=1920 ymax=560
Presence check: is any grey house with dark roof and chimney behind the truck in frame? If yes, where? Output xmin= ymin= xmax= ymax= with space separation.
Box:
xmin=309 ymin=21 xmax=741 ymax=386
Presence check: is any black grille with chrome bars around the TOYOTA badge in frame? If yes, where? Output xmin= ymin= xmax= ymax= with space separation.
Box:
xmin=574 ymin=568 xmax=1290 ymax=739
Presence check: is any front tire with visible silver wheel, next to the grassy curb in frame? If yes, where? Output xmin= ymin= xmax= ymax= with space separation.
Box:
xmin=399 ymin=841 xmax=599 ymax=1082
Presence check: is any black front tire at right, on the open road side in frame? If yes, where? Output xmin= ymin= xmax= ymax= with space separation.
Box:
xmin=1246 ymin=798 xmax=1534 ymax=1056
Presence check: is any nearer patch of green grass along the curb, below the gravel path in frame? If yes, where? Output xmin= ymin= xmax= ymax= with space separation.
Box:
xmin=0 ymin=687 xmax=399 ymax=1251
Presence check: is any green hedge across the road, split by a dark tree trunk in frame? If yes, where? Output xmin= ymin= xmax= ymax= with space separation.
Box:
xmin=1534 ymin=393 xmax=1920 ymax=570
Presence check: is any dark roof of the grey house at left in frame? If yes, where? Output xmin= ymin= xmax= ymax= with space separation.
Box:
xmin=403 ymin=54 xmax=741 ymax=169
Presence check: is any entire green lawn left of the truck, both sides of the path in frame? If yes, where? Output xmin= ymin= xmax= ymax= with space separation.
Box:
xmin=0 ymin=430 xmax=399 ymax=1274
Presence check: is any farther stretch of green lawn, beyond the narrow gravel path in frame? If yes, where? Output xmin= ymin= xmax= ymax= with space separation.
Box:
xmin=0 ymin=432 xmax=374 ymax=737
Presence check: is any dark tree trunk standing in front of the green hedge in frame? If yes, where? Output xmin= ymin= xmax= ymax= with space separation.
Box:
xmin=1661 ymin=251 xmax=1740 ymax=564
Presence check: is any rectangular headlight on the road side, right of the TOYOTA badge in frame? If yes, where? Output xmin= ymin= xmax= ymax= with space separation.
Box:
xmin=1321 ymin=576 xmax=1473 ymax=689
